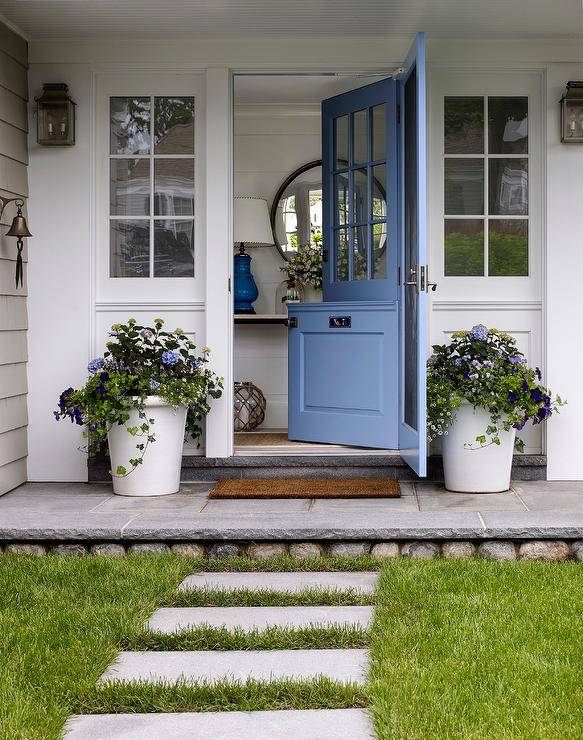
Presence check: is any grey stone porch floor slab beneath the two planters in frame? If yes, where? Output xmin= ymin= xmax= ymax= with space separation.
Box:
xmin=0 ymin=481 xmax=583 ymax=541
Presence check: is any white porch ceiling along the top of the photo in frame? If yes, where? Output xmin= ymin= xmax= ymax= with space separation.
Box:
xmin=0 ymin=0 xmax=583 ymax=39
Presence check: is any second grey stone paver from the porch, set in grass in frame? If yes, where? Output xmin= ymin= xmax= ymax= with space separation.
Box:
xmin=147 ymin=606 xmax=373 ymax=635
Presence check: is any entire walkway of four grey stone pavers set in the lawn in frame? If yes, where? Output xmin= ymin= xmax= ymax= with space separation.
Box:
xmin=65 ymin=572 xmax=378 ymax=740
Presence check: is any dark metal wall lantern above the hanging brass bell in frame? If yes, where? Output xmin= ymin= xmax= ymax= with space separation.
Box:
xmin=35 ymin=82 xmax=76 ymax=146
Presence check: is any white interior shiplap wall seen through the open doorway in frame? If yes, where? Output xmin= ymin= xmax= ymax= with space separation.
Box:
xmin=234 ymin=105 xmax=321 ymax=429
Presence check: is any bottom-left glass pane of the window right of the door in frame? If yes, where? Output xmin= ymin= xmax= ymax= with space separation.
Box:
xmin=445 ymin=218 xmax=484 ymax=276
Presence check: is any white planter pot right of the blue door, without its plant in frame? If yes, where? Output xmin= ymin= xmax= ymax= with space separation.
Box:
xmin=442 ymin=402 xmax=516 ymax=493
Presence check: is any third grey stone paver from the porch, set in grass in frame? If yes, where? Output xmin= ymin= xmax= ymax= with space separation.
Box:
xmin=100 ymin=650 xmax=368 ymax=684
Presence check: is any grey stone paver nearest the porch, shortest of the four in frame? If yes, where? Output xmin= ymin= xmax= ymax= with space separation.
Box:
xmin=179 ymin=572 xmax=379 ymax=594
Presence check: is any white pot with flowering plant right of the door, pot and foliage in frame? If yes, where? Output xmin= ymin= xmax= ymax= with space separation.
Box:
xmin=427 ymin=324 xmax=565 ymax=493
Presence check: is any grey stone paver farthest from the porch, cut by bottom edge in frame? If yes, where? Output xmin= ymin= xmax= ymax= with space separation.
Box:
xmin=64 ymin=709 xmax=374 ymax=740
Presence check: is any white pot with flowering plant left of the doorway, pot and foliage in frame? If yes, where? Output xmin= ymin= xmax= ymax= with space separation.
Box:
xmin=54 ymin=319 xmax=222 ymax=496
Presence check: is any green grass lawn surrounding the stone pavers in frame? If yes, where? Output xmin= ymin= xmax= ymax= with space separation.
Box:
xmin=0 ymin=555 xmax=583 ymax=740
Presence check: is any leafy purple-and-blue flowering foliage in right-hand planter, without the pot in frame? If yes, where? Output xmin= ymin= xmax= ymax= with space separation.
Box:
xmin=427 ymin=324 xmax=565 ymax=451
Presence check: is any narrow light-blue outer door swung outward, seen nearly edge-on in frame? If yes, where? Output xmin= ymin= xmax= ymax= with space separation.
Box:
xmin=399 ymin=33 xmax=428 ymax=476
